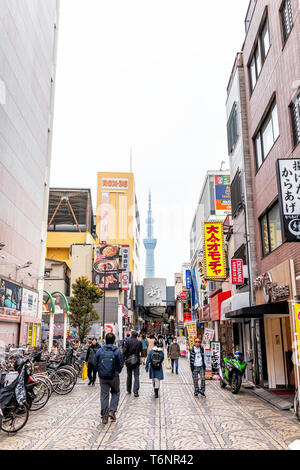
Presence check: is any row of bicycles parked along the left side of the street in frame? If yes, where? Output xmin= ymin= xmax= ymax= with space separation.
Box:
xmin=0 ymin=348 xmax=83 ymax=433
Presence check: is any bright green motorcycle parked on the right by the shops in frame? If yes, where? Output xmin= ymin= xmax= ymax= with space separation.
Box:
xmin=219 ymin=351 xmax=247 ymax=394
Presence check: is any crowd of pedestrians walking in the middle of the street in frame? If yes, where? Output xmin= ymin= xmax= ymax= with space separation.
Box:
xmin=85 ymin=331 xmax=205 ymax=424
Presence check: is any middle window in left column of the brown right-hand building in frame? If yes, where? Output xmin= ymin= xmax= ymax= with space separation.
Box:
xmin=254 ymin=102 xmax=279 ymax=169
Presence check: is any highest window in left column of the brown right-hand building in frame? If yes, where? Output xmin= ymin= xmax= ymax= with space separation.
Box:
xmin=248 ymin=18 xmax=271 ymax=92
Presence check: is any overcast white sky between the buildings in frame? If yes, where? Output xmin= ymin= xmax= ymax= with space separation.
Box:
xmin=51 ymin=0 xmax=249 ymax=285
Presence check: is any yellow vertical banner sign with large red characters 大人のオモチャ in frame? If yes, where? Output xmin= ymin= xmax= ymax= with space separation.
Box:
xmin=203 ymin=221 xmax=226 ymax=280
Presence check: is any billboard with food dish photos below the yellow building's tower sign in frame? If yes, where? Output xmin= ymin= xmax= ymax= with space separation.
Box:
xmin=93 ymin=245 xmax=120 ymax=290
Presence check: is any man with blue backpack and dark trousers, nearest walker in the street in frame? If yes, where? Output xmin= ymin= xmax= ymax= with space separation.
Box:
xmin=95 ymin=333 xmax=124 ymax=424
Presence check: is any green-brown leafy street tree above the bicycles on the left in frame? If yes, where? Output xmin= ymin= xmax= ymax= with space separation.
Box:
xmin=69 ymin=276 xmax=103 ymax=342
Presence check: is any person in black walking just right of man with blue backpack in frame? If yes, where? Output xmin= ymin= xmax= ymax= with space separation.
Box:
xmin=123 ymin=331 xmax=142 ymax=397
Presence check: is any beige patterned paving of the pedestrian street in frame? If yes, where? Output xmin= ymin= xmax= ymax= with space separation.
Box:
xmin=0 ymin=359 xmax=300 ymax=450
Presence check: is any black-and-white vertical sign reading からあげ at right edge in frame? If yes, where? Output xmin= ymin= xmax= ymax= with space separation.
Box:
xmin=277 ymin=158 xmax=300 ymax=242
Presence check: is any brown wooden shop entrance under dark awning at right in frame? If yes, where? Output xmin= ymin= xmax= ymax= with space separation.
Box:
xmin=264 ymin=316 xmax=295 ymax=389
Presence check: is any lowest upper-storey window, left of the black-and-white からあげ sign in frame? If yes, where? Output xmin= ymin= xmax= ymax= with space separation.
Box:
xmin=260 ymin=202 xmax=282 ymax=256
